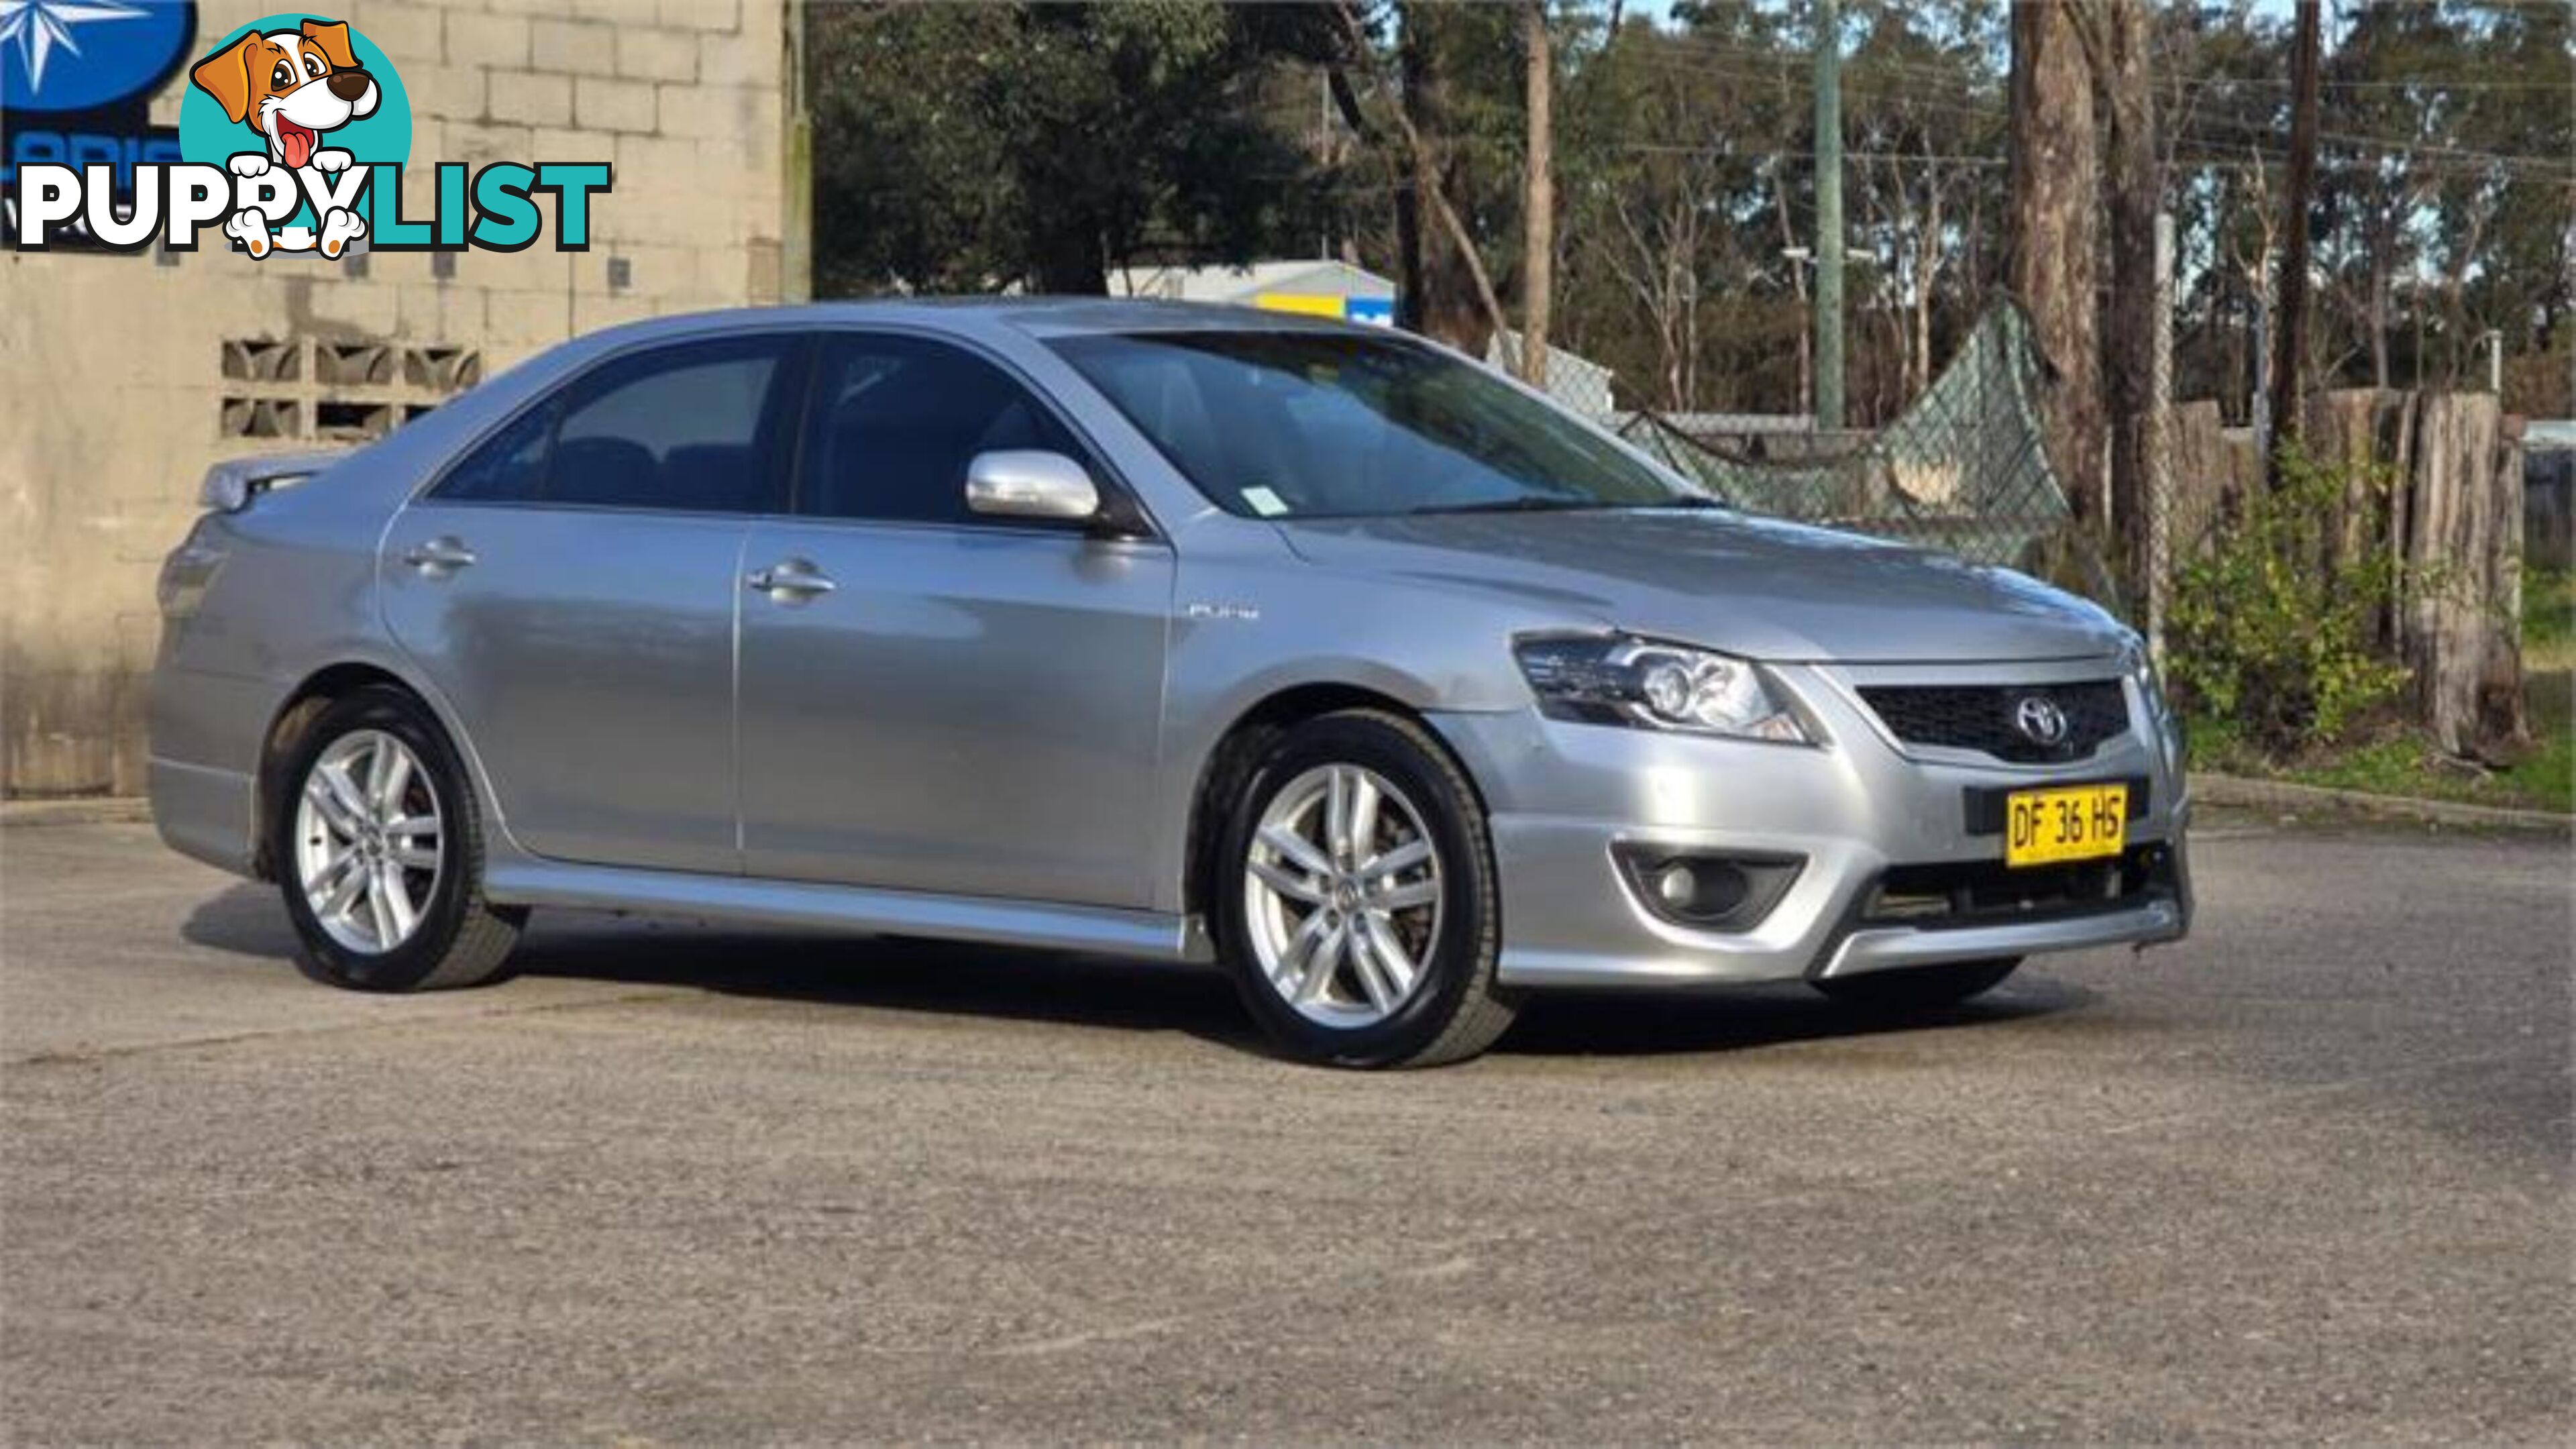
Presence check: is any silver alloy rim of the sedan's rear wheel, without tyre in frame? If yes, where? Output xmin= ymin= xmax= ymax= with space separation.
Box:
xmin=297 ymin=730 xmax=443 ymax=954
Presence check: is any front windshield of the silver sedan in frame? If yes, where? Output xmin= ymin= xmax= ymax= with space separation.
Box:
xmin=1054 ymin=333 xmax=1708 ymax=519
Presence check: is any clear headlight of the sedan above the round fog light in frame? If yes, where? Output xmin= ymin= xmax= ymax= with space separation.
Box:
xmin=1512 ymin=634 xmax=1813 ymax=745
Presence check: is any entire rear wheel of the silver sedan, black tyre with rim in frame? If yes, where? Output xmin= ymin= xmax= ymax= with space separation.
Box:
xmin=268 ymin=686 xmax=528 ymax=993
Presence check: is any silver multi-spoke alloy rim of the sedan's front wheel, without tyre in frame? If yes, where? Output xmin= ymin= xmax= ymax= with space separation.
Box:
xmin=1244 ymin=763 xmax=1442 ymax=1029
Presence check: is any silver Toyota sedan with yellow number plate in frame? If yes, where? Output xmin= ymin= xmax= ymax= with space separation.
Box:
xmin=152 ymin=302 xmax=2192 ymax=1067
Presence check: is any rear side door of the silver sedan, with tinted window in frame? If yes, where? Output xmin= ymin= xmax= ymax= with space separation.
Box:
xmin=381 ymin=335 xmax=801 ymax=874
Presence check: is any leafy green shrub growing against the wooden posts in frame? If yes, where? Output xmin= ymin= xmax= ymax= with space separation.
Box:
xmin=2166 ymin=451 xmax=2408 ymax=753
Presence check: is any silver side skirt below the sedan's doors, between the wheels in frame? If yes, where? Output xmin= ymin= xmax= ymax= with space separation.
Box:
xmin=484 ymin=859 xmax=1214 ymax=962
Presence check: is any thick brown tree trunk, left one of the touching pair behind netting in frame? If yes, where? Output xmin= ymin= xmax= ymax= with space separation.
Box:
xmin=2009 ymin=0 xmax=2104 ymax=536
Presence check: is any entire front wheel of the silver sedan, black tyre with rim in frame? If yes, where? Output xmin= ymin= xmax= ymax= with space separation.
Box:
xmin=1208 ymin=709 xmax=1517 ymax=1067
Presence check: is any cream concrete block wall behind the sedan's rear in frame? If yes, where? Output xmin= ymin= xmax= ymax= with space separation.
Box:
xmin=0 ymin=0 xmax=791 ymax=797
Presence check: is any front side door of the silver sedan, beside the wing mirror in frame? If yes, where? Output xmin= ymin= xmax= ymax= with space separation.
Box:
xmin=742 ymin=333 xmax=1172 ymax=905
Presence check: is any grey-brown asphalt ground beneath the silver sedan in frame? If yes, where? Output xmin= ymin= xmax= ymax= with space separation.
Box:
xmin=0 ymin=825 xmax=2576 ymax=1444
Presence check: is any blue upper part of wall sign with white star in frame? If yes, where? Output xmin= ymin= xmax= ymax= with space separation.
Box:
xmin=0 ymin=0 xmax=196 ymax=111
